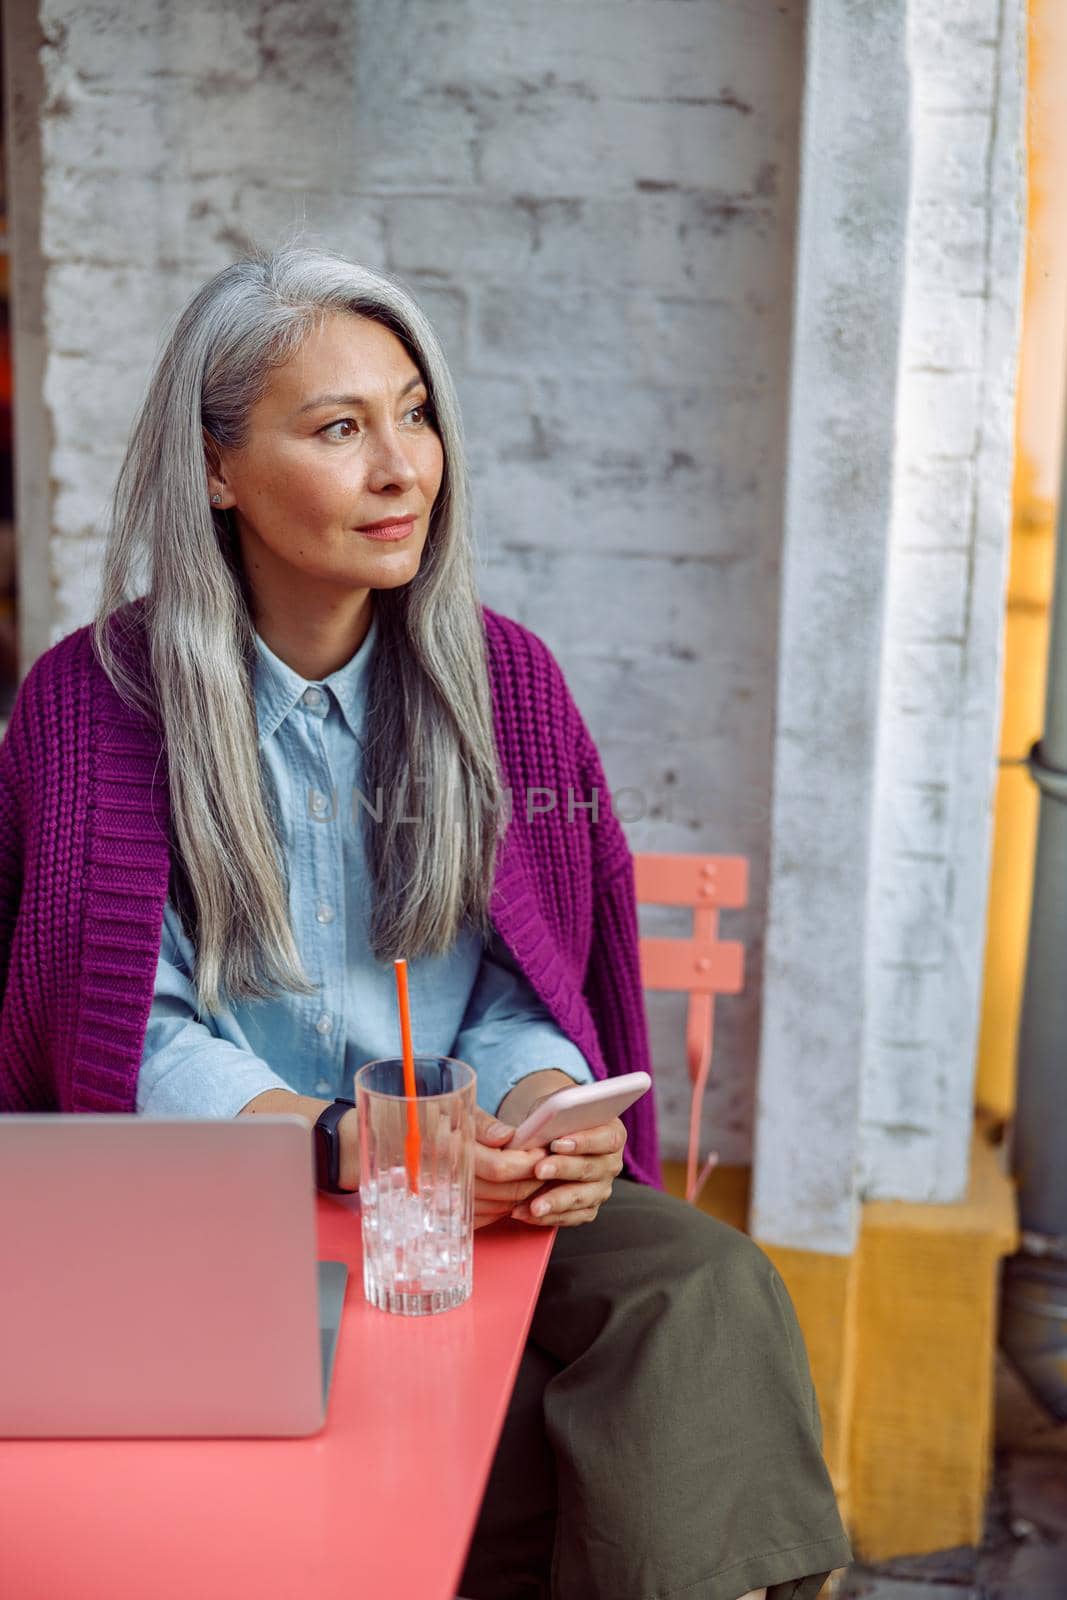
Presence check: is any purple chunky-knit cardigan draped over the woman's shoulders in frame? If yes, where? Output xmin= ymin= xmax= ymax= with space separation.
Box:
xmin=0 ymin=600 xmax=661 ymax=1187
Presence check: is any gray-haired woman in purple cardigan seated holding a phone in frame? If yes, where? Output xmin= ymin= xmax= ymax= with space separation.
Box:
xmin=0 ymin=248 xmax=849 ymax=1600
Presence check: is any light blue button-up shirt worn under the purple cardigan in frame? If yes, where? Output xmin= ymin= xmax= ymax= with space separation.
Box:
xmin=136 ymin=604 xmax=593 ymax=1117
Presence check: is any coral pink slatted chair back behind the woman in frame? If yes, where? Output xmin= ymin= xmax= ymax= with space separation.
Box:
xmin=633 ymin=854 xmax=749 ymax=1205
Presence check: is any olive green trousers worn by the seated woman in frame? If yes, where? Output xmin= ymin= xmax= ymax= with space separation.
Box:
xmin=459 ymin=1179 xmax=851 ymax=1600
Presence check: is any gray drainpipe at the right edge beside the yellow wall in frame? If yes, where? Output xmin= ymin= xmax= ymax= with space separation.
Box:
xmin=1000 ymin=403 xmax=1067 ymax=1419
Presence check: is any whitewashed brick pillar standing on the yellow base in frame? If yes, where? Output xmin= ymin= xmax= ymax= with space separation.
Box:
xmin=752 ymin=0 xmax=1025 ymax=1253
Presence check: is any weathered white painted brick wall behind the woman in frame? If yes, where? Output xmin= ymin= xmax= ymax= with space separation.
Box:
xmin=10 ymin=0 xmax=803 ymax=1160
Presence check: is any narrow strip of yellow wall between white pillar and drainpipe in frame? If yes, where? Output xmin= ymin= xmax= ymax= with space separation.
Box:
xmin=976 ymin=0 xmax=1067 ymax=1118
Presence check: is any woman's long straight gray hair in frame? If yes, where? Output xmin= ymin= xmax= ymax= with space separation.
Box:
xmin=93 ymin=243 xmax=502 ymax=1011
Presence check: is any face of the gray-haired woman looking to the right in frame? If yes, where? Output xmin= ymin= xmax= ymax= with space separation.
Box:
xmin=210 ymin=312 xmax=445 ymax=610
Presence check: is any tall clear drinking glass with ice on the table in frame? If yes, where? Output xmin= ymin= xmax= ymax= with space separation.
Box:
xmin=355 ymin=1056 xmax=475 ymax=1317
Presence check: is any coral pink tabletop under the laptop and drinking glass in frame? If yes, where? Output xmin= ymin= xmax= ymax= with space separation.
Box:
xmin=0 ymin=1195 xmax=555 ymax=1600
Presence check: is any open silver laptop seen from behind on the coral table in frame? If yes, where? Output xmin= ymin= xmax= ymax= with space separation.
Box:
xmin=0 ymin=1115 xmax=347 ymax=1438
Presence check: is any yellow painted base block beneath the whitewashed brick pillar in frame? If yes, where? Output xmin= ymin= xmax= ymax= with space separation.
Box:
xmin=846 ymin=1130 xmax=1017 ymax=1562
